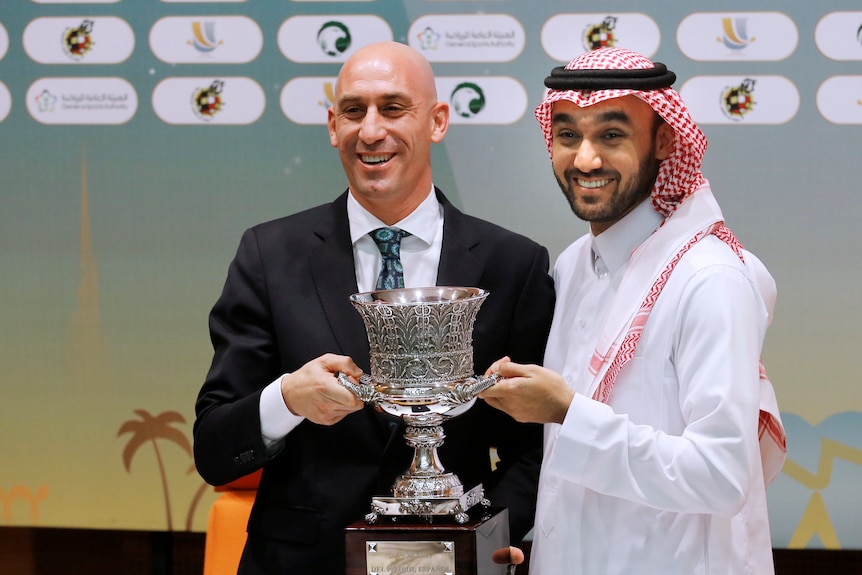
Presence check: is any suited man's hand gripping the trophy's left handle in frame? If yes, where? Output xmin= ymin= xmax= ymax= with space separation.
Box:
xmin=281 ymin=353 xmax=365 ymax=425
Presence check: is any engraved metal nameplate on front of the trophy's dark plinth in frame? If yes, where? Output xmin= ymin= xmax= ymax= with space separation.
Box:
xmin=365 ymin=541 xmax=455 ymax=575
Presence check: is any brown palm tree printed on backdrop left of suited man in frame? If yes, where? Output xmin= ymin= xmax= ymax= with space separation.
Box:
xmin=117 ymin=409 xmax=192 ymax=531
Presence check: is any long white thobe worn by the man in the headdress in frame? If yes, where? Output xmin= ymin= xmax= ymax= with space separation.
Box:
xmin=530 ymin=190 xmax=774 ymax=575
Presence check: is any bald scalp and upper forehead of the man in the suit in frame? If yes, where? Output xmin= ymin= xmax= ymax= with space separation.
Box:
xmin=335 ymin=42 xmax=437 ymax=102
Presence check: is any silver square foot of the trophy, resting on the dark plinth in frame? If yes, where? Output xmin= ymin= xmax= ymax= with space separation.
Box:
xmin=365 ymin=485 xmax=491 ymax=525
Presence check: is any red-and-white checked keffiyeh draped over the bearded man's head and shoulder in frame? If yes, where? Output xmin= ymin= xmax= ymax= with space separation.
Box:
xmin=535 ymin=48 xmax=787 ymax=484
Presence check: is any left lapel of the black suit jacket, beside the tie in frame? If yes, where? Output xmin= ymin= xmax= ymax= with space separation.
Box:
xmin=309 ymin=193 xmax=369 ymax=372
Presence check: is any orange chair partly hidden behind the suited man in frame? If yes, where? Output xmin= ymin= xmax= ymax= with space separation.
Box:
xmin=204 ymin=470 xmax=261 ymax=575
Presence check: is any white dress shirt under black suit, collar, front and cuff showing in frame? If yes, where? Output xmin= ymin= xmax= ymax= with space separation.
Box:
xmin=260 ymin=186 xmax=443 ymax=449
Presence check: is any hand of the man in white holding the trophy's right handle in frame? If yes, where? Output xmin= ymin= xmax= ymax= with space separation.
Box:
xmin=479 ymin=357 xmax=575 ymax=423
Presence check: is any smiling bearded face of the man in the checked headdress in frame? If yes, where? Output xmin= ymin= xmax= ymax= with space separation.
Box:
xmin=551 ymin=96 xmax=674 ymax=235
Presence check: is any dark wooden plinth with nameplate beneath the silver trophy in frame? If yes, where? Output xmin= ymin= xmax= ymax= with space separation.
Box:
xmin=345 ymin=507 xmax=509 ymax=575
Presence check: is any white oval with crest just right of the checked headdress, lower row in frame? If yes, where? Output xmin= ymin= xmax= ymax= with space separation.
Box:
xmin=679 ymin=76 xmax=799 ymax=124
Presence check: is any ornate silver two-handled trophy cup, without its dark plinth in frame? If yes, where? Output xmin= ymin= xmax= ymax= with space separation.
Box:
xmin=338 ymin=287 xmax=497 ymax=524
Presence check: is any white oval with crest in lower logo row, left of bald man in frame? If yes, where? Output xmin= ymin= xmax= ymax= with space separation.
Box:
xmin=153 ymin=77 xmax=266 ymax=125
